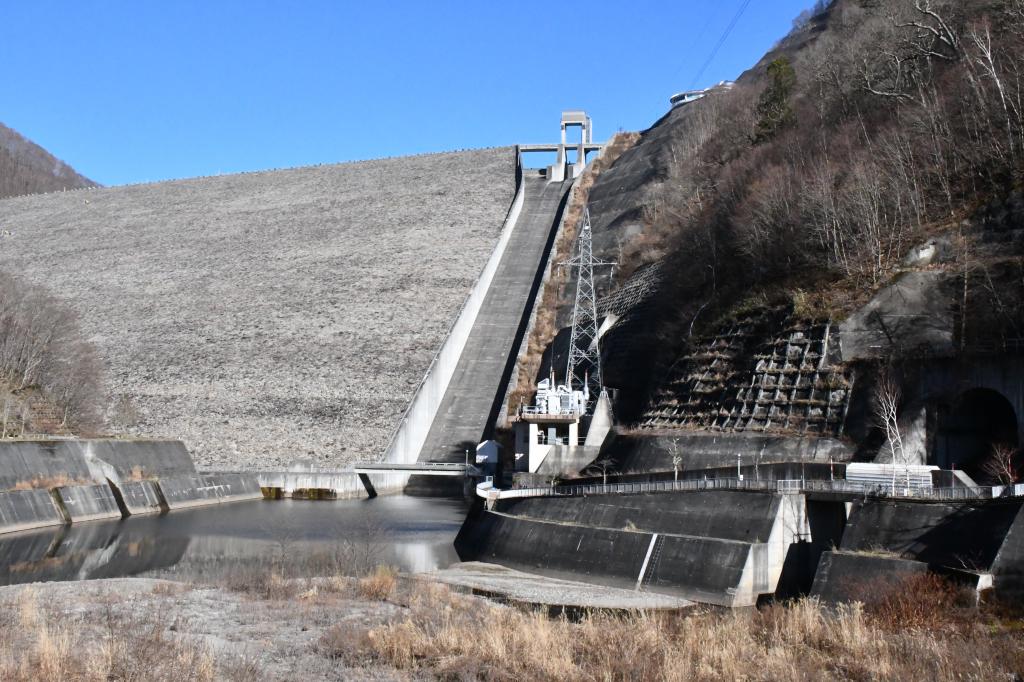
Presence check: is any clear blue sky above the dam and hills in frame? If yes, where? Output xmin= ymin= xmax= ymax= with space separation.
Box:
xmin=0 ymin=0 xmax=812 ymax=184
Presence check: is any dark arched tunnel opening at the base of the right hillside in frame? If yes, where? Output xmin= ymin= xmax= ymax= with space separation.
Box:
xmin=935 ymin=388 xmax=1020 ymax=478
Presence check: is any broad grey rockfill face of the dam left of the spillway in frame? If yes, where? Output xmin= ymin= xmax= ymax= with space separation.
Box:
xmin=0 ymin=147 xmax=515 ymax=469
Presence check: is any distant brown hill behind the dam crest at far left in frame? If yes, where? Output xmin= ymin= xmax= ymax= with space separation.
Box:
xmin=0 ymin=123 xmax=96 ymax=199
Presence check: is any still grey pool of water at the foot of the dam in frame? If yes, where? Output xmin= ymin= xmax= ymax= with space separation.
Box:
xmin=0 ymin=497 xmax=465 ymax=585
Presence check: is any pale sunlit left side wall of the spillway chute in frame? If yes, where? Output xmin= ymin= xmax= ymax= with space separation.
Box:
xmin=382 ymin=148 xmax=524 ymax=481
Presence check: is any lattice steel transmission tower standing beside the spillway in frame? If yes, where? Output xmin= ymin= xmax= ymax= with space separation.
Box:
xmin=559 ymin=208 xmax=614 ymax=413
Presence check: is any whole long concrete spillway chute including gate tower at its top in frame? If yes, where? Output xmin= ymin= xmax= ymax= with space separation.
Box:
xmin=362 ymin=112 xmax=601 ymax=496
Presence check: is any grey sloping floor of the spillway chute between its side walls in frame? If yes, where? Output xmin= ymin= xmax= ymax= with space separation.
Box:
xmin=406 ymin=171 xmax=571 ymax=495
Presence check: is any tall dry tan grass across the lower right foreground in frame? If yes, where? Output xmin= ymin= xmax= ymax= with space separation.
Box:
xmin=318 ymin=586 xmax=1024 ymax=680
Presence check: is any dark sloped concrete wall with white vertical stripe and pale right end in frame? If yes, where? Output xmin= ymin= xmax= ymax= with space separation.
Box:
xmin=456 ymin=491 xmax=811 ymax=606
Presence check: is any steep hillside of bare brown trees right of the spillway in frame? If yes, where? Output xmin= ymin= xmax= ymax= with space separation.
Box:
xmin=591 ymin=0 xmax=1024 ymax=417
